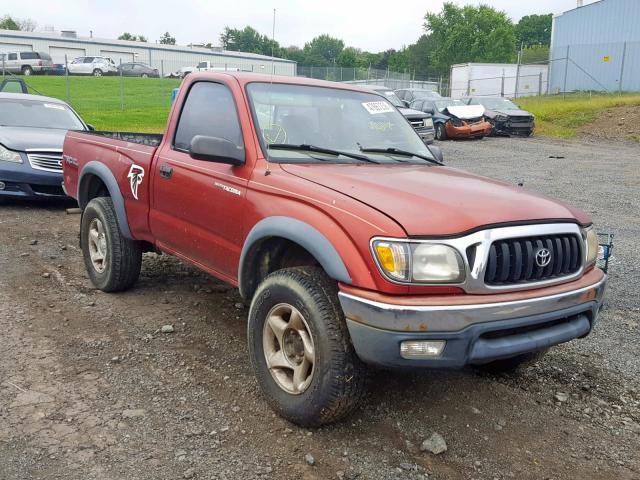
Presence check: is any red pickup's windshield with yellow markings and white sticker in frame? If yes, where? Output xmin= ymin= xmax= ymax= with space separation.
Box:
xmin=247 ymin=83 xmax=433 ymax=163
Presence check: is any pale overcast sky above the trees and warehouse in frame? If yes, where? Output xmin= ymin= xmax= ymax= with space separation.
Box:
xmin=6 ymin=0 xmax=593 ymax=52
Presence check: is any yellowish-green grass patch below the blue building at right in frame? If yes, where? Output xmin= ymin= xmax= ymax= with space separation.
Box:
xmin=517 ymin=93 xmax=640 ymax=138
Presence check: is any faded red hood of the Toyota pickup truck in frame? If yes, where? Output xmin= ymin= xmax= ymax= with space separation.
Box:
xmin=281 ymin=164 xmax=591 ymax=235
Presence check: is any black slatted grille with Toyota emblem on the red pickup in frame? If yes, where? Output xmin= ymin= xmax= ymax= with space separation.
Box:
xmin=484 ymin=234 xmax=583 ymax=285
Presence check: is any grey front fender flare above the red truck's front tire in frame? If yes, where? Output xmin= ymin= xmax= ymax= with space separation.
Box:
xmin=238 ymin=216 xmax=352 ymax=299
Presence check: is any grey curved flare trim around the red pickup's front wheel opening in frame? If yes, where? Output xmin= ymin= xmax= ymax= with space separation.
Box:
xmin=238 ymin=216 xmax=352 ymax=298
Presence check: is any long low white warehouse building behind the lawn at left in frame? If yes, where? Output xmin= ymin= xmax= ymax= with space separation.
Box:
xmin=0 ymin=30 xmax=296 ymax=75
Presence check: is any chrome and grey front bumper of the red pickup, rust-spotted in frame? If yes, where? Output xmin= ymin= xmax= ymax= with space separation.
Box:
xmin=339 ymin=270 xmax=606 ymax=368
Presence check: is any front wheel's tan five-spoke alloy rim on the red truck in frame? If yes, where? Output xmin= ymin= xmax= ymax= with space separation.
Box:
xmin=262 ymin=303 xmax=315 ymax=395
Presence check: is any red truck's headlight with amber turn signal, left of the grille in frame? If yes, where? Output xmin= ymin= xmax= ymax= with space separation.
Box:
xmin=372 ymin=240 xmax=465 ymax=283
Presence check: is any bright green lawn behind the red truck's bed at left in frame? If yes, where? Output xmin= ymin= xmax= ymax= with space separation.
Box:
xmin=7 ymin=75 xmax=180 ymax=133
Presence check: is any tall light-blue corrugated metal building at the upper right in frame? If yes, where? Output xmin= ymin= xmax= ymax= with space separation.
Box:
xmin=549 ymin=0 xmax=640 ymax=93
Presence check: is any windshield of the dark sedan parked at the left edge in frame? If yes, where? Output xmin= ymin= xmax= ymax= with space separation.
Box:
xmin=0 ymin=99 xmax=84 ymax=130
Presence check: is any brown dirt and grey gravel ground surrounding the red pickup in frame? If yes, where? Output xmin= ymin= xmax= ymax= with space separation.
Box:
xmin=0 ymin=138 xmax=640 ymax=480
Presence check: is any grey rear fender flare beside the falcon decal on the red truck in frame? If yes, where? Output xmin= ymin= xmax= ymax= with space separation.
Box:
xmin=77 ymin=160 xmax=133 ymax=239
